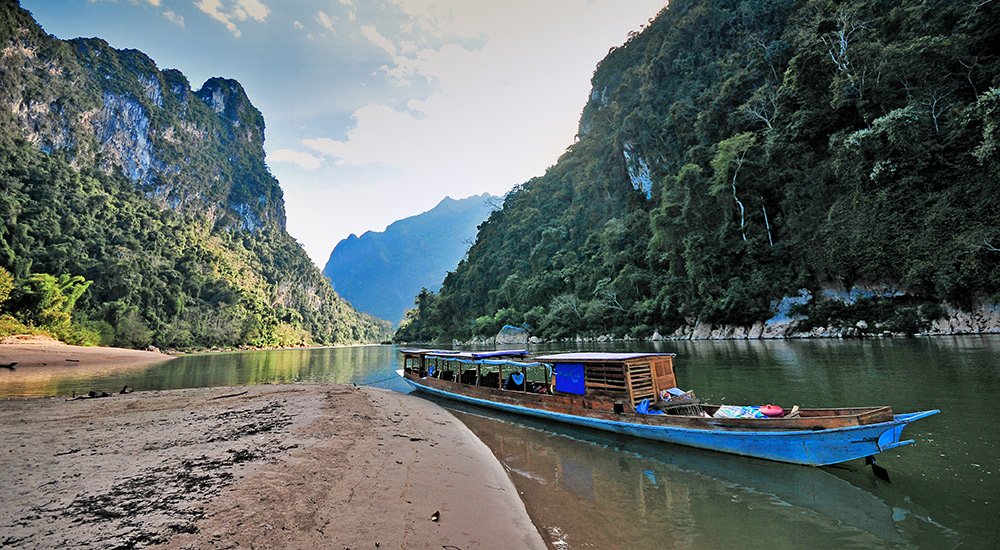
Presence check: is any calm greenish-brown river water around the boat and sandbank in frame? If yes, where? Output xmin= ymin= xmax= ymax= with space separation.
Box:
xmin=0 ymin=336 xmax=1000 ymax=549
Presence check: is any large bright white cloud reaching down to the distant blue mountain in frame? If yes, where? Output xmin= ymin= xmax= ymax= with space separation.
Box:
xmin=278 ymin=0 xmax=663 ymax=265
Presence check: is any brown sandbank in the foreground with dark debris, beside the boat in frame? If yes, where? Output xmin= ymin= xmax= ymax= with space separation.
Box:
xmin=0 ymin=384 xmax=545 ymax=548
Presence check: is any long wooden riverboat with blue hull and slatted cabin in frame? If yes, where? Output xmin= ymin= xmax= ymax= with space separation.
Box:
xmin=398 ymin=349 xmax=940 ymax=466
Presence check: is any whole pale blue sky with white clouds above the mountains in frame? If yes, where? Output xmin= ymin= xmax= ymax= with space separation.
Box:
xmin=21 ymin=0 xmax=666 ymax=268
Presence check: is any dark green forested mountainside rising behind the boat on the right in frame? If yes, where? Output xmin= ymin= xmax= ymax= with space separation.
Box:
xmin=395 ymin=0 xmax=1000 ymax=341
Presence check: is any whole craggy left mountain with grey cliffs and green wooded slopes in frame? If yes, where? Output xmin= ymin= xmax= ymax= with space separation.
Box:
xmin=0 ymin=2 xmax=391 ymax=349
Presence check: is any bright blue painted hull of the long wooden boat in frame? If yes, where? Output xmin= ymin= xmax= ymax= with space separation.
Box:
xmin=403 ymin=376 xmax=940 ymax=466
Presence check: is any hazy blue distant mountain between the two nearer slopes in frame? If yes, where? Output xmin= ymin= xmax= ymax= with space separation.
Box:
xmin=323 ymin=193 xmax=494 ymax=323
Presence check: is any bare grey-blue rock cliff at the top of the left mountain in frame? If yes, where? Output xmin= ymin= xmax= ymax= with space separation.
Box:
xmin=0 ymin=23 xmax=285 ymax=231
